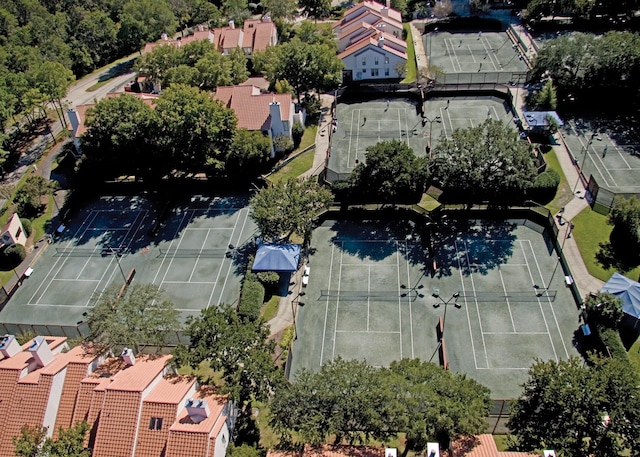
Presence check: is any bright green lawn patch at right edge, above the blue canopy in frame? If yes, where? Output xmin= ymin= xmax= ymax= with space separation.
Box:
xmin=572 ymin=204 xmax=640 ymax=281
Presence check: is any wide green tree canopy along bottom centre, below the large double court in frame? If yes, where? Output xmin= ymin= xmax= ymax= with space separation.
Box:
xmin=271 ymin=358 xmax=491 ymax=451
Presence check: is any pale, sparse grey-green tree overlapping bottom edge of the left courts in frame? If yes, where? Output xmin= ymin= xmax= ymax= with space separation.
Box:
xmin=87 ymin=284 xmax=180 ymax=352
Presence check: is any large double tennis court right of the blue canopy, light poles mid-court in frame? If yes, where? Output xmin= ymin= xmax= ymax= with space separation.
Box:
xmin=291 ymin=216 xmax=578 ymax=398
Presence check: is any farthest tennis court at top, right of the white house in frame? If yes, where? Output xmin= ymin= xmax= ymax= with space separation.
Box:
xmin=423 ymin=32 xmax=527 ymax=77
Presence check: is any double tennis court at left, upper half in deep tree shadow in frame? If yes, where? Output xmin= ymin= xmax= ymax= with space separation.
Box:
xmin=0 ymin=192 xmax=256 ymax=326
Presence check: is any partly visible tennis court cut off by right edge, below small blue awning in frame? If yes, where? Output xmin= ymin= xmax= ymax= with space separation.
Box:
xmin=562 ymin=120 xmax=640 ymax=193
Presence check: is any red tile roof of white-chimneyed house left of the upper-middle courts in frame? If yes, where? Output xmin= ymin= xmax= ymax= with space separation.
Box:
xmin=214 ymin=86 xmax=291 ymax=131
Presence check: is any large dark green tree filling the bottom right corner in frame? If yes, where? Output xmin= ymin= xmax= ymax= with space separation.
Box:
xmin=508 ymin=358 xmax=640 ymax=457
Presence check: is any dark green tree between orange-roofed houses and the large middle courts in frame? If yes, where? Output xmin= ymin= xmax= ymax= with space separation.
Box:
xmin=175 ymin=305 xmax=281 ymax=410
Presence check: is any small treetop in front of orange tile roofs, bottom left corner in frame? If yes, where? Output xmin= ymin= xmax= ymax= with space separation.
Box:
xmin=13 ymin=421 xmax=91 ymax=457
